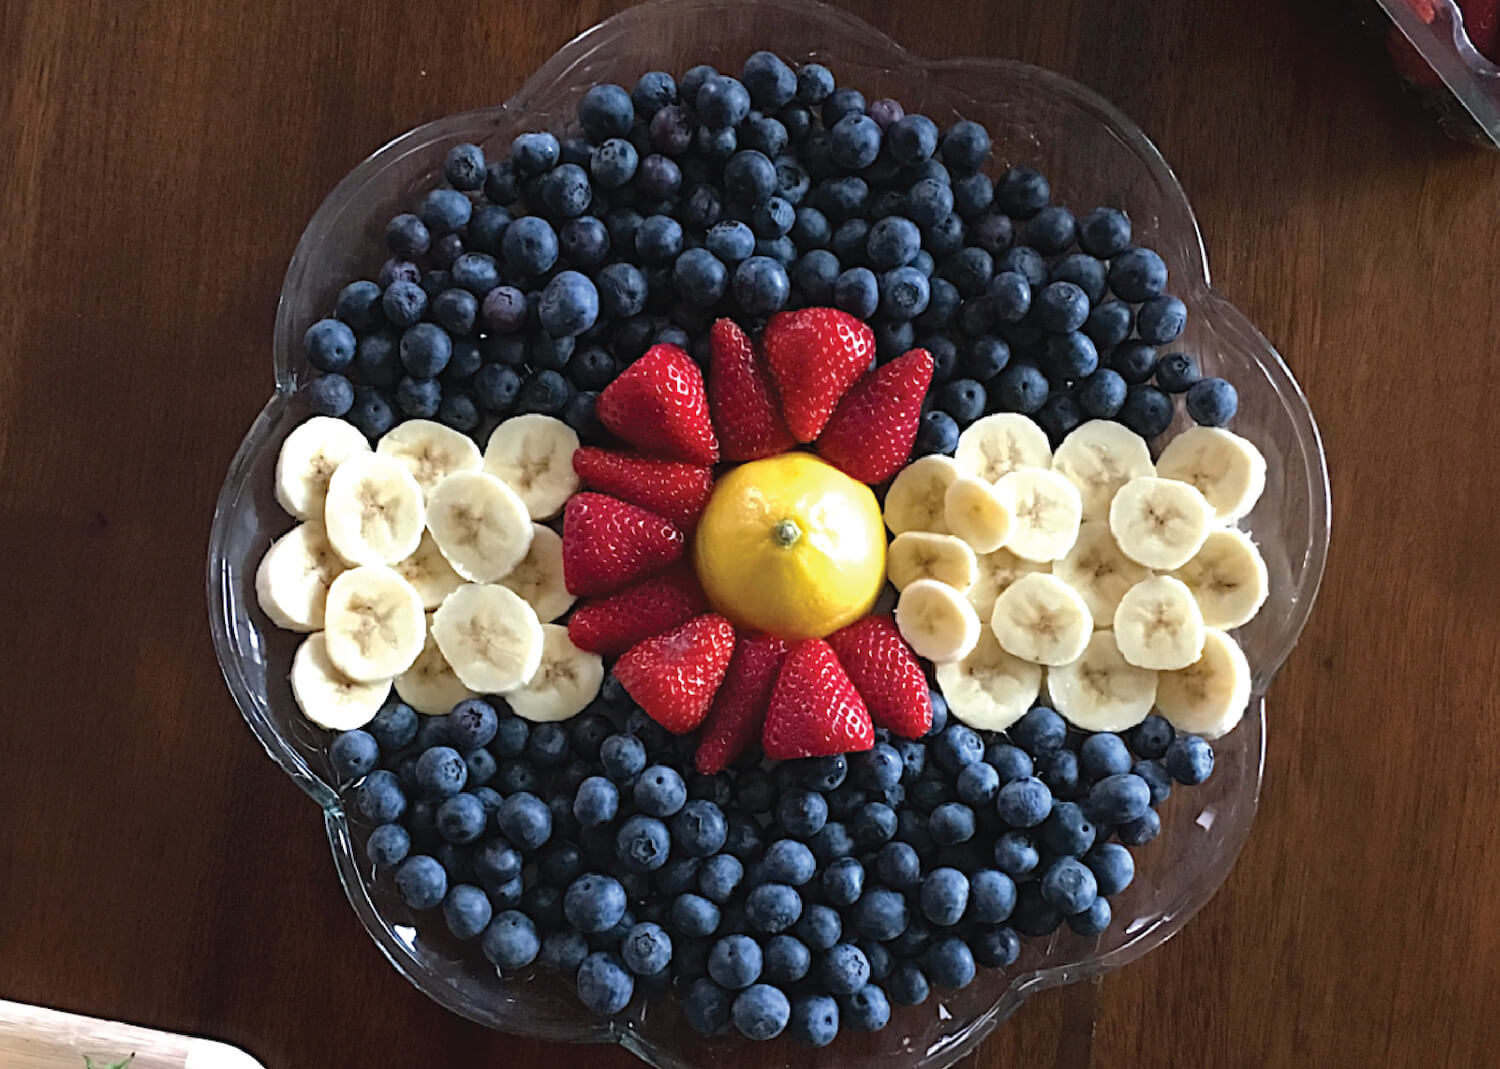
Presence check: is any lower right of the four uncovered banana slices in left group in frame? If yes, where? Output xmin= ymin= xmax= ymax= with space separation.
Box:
xmin=432 ymin=584 xmax=542 ymax=694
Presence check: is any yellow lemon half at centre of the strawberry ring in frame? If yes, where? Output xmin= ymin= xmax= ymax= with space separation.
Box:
xmin=693 ymin=453 xmax=885 ymax=639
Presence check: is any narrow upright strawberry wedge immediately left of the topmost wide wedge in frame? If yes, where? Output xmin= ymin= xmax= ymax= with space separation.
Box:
xmin=708 ymin=319 xmax=797 ymax=460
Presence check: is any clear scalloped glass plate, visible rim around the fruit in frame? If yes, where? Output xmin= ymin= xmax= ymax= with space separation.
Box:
xmin=209 ymin=0 xmax=1329 ymax=1069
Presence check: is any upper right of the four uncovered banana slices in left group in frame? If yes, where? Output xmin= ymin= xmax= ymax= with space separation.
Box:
xmin=428 ymin=471 xmax=534 ymax=583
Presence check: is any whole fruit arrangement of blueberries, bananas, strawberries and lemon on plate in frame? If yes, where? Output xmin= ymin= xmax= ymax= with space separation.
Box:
xmin=257 ymin=52 xmax=1269 ymax=1047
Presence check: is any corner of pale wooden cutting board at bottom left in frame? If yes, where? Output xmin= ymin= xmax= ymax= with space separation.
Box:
xmin=0 ymin=1000 xmax=266 ymax=1069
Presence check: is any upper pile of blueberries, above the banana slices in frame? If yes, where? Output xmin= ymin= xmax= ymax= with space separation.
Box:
xmin=295 ymin=52 xmax=1238 ymax=454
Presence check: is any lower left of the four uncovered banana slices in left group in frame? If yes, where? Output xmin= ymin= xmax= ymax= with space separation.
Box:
xmin=324 ymin=565 xmax=428 ymax=682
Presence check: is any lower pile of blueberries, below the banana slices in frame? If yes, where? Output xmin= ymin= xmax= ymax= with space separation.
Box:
xmin=330 ymin=676 xmax=1214 ymax=1047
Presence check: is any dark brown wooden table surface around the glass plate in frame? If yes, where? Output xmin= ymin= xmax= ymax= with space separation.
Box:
xmin=0 ymin=0 xmax=1500 ymax=1068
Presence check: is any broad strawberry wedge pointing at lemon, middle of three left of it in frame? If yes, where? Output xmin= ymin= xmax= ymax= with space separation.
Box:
xmin=563 ymin=492 xmax=687 ymax=598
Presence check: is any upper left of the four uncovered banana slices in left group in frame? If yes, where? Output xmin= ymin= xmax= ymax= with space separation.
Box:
xmin=323 ymin=453 xmax=422 ymax=564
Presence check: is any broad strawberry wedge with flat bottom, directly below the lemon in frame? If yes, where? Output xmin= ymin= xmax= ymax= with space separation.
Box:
xmin=768 ymin=639 xmax=875 ymax=760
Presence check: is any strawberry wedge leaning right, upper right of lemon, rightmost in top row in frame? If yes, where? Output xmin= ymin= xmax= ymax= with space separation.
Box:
xmin=818 ymin=349 xmax=933 ymax=484
